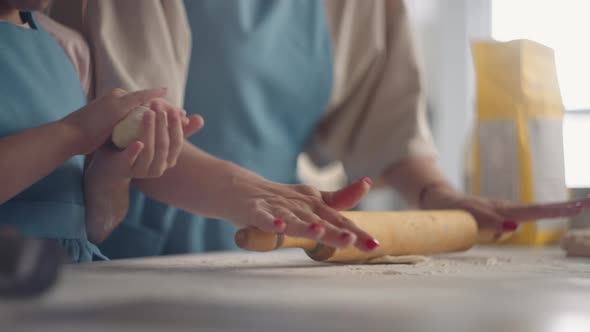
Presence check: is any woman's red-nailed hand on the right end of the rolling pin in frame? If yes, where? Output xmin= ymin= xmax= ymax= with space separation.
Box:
xmin=421 ymin=186 xmax=590 ymax=241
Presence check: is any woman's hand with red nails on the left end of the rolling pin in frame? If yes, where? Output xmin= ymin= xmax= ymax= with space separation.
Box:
xmin=231 ymin=178 xmax=379 ymax=251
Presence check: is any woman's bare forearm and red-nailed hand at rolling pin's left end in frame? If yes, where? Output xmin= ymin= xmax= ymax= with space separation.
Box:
xmin=134 ymin=143 xmax=378 ymax=251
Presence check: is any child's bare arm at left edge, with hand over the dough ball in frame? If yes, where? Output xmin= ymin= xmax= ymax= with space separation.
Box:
xmin=0 ymin=89 xmax=166 ymax=204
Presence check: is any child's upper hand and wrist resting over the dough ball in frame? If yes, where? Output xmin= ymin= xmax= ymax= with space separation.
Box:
xmin=61 ymin=89 xmax=167 ymax=154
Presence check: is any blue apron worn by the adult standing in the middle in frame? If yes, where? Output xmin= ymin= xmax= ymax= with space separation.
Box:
xmin=101 ymin=0 xmax=333 ymax=258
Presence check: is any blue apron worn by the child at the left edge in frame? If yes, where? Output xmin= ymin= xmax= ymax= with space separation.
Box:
xmin=0 ymin=13 xmax=101 ymax=262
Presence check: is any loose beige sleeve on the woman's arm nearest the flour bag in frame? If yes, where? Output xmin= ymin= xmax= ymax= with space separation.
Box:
xmin=307 ymin=0 xmax=436 ymax=179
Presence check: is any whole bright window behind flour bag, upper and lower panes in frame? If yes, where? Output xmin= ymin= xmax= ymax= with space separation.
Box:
xmin=492 ymin=0 xmax=590 ymax=188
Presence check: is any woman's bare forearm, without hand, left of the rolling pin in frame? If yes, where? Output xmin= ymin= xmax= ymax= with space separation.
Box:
xmin=134 ymin=143 xmax=266 ymax=220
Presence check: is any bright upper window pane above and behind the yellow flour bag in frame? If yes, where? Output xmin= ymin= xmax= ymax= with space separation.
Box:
xmin=492 ymin=0 xmax=590 ymax=110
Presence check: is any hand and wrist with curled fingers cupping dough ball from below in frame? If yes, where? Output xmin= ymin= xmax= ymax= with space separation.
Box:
xmin=85 ymin=101 xmax=203 ymax=243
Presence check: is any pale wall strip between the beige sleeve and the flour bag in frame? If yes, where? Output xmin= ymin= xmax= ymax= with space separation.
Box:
xmin=407 ymin=0 xmax=491 ymax=188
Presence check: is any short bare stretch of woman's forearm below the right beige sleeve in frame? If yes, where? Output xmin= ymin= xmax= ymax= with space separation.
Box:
xmin=385 ymin=158 xmax=455 ymax=207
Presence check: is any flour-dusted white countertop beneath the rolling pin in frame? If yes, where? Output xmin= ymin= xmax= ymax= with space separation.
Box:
xmin=0 ymin=247 xmax=590 ymax=332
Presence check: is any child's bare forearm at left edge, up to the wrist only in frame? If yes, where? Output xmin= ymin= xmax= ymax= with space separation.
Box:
xmin=0 ymin=121 xmax=77 ymax=204
